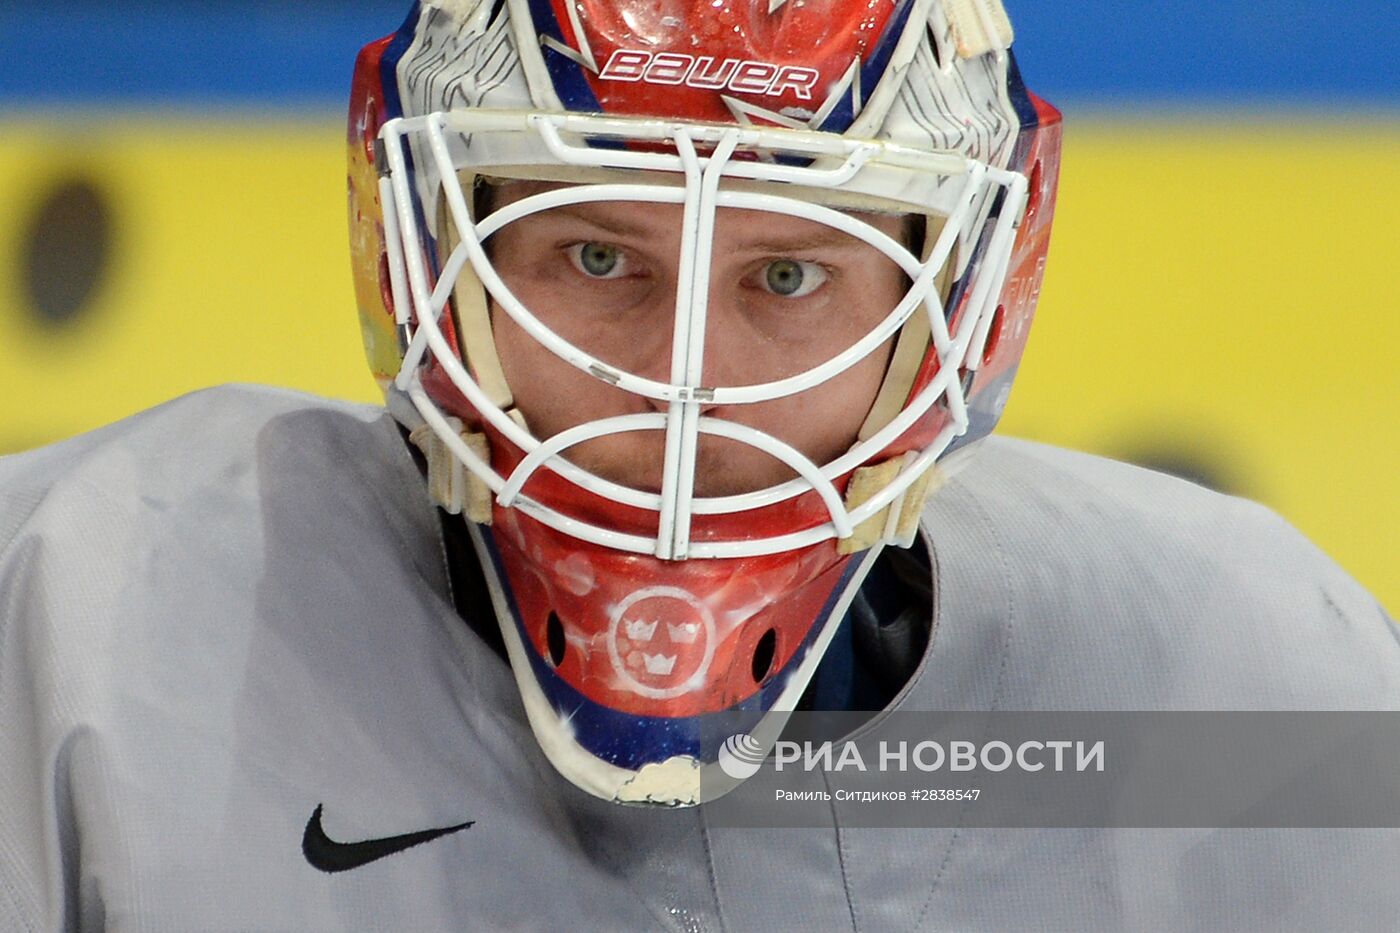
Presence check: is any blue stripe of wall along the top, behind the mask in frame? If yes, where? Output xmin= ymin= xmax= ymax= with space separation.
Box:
xmin=0 ymin=0 xmax=1400 ymax=108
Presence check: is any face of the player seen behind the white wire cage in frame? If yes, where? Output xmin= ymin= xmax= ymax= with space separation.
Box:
xmin=487 ymin=182 xmax=909 ymax=496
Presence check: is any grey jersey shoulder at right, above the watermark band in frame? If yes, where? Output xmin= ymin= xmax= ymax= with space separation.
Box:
xmin=925 ymin=437 xmax=1400 ymax=709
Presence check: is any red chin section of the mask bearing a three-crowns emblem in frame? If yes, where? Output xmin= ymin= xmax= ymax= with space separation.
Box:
xmin=494 ymin=509 xmax=850 ymax=717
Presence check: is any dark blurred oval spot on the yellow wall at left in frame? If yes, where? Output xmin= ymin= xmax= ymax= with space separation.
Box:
xmin=20 ymin=175 xmax=115 ymax=326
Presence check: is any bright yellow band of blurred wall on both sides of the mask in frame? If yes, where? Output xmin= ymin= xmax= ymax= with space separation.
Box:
xmin=0 ymin=113 xmax=1400 ymax=607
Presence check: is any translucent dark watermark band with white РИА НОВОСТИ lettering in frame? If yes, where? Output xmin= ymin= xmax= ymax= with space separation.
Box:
xmin=703 ymin=712 xmax=1400 ymax=828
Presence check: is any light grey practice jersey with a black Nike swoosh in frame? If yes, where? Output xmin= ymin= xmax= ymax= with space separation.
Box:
xmin=0 ymin=388 xmax=1400 ymax=932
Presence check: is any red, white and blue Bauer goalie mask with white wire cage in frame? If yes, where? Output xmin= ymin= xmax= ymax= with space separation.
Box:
xmin=349 ymin=0 xmax=1060 ymax=806
